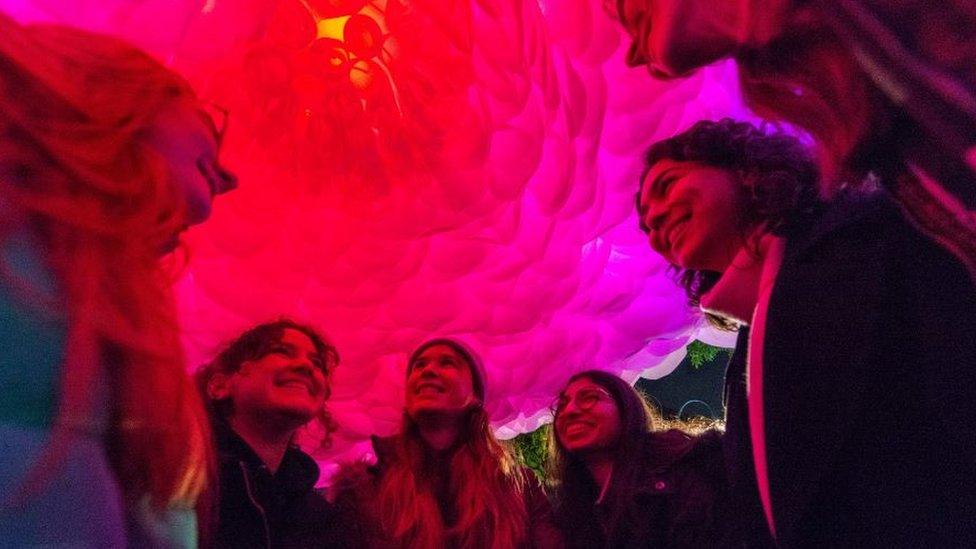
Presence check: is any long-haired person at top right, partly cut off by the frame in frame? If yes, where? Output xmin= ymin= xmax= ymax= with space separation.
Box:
xmin=617 ymin=0 xmax=976 ymax=279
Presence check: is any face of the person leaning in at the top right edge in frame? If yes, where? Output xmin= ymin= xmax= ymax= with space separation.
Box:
xmin=617 ymin=0 xmax=742 ymax=78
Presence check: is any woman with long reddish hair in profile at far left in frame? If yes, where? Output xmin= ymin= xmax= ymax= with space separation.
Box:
xmin=0 ymin=11 xmax=234 ymax=547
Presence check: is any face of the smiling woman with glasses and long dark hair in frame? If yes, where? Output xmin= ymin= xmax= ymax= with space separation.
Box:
xmin=553 ymin=377 xmax=621 ymax=453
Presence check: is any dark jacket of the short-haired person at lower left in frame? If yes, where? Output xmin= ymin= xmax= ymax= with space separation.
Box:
xmin=213 ymin=422 xmax=342 ymax=549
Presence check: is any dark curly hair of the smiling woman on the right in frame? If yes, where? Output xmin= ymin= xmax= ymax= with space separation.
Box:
xmin=637 ymin=118 xmax=821 ymax=328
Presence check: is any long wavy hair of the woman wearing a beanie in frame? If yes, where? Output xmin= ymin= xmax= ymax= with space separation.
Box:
xmin=378 ymin=343 xmax=528 ymax=549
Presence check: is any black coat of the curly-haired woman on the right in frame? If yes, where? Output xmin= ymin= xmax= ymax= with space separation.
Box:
xmin=727 ymin=189 xmax=976 ymax=547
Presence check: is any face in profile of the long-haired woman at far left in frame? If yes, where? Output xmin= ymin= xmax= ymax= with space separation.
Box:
xmin=146 ymin=101 xmax=237 ymax=225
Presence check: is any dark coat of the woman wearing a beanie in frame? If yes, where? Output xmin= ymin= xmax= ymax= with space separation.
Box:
xmin=332 ymin=436 xmax=563 ymax=549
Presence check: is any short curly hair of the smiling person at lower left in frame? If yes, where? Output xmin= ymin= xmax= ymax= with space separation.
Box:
xmin=194 ymin=318 xmax=339 ymax=445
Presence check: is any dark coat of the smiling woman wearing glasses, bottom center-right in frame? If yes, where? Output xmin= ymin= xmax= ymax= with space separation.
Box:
xmin=556 ymin=430 xmax=734 ymax=549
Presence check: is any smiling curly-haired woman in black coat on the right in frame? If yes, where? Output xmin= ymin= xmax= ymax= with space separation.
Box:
xmin=638 ymin=119 xmax=976 ymax=546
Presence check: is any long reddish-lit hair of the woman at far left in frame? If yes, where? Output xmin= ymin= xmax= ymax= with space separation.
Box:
xmin=0 ymin=11 xmax=211 ymax=509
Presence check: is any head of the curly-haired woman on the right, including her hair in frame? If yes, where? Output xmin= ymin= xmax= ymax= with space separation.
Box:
xmin=637 ymin=118 xmax=821 ymax=316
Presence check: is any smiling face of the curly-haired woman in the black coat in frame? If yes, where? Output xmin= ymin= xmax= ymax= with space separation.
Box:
xmin=638 ymin=159 xmax=744 ymax=272
